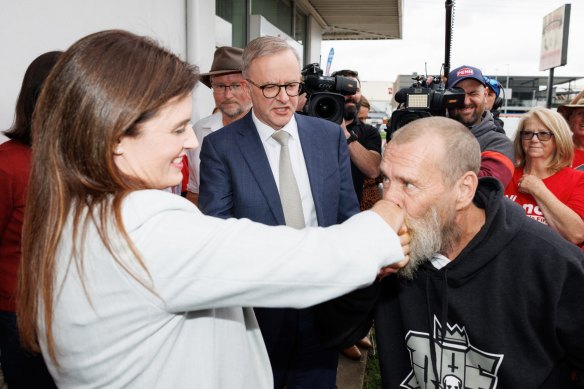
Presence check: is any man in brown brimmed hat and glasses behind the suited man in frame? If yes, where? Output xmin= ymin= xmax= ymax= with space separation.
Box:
xmin=187 ymin=46 xmax=251 ymax=205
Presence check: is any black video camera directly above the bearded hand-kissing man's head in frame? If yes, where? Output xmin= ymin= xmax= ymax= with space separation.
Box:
xmin=387 ymin=77 xmax=465 ymax=140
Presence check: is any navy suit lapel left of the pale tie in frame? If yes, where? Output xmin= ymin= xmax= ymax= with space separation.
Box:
xmin=238 ymin=110 xmax=286 ymax=225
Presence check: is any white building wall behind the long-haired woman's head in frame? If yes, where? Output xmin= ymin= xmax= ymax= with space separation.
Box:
xmin=0 ymin=0 xmax=215 ymax=130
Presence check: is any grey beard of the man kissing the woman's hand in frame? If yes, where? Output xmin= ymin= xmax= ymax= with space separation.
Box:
xmin=397 ymin=207 xmax=460 ymax=280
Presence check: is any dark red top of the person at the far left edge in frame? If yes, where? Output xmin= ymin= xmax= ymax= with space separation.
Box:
xmin=0 ymin=140 xmax=31 ymax=312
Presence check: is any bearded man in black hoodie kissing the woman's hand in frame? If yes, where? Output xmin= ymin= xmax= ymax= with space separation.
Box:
xmin=318 ymin=117 xmax=584 ymax=389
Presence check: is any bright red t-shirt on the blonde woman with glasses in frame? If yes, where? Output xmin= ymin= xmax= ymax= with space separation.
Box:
xmin=505 ymin=167 xmax=584 ymax=224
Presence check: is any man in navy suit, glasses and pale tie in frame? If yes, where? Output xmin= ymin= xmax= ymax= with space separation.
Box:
xmin=199 ymin=37 xmax=359 ymax=388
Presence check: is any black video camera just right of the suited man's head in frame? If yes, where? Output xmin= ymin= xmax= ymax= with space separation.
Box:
xmin=302 ymin=63 xmax=357 ymax=124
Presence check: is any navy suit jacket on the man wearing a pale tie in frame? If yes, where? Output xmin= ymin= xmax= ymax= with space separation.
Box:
xmin=199 ymin=111 xmax=359 ymax=355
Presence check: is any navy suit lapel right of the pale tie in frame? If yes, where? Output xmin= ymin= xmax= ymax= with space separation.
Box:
xmin=295 ymin=114 xmax=326 ymax=224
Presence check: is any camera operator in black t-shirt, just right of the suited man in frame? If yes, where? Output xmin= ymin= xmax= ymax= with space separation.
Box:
xmin=332 ymin=70 xmax=381 ymax=203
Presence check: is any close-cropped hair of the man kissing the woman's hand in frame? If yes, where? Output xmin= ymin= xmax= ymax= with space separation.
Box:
xmin=391 ymin=116 xmax=481 ymax=184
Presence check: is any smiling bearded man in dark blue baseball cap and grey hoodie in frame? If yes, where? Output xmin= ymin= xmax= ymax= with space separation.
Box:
xmin=446 ymin=65 xmax=515 ymax=187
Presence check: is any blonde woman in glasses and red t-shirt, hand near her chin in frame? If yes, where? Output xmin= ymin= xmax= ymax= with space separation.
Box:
xmin=505 ymin=107 xmax=584 ymax=246
